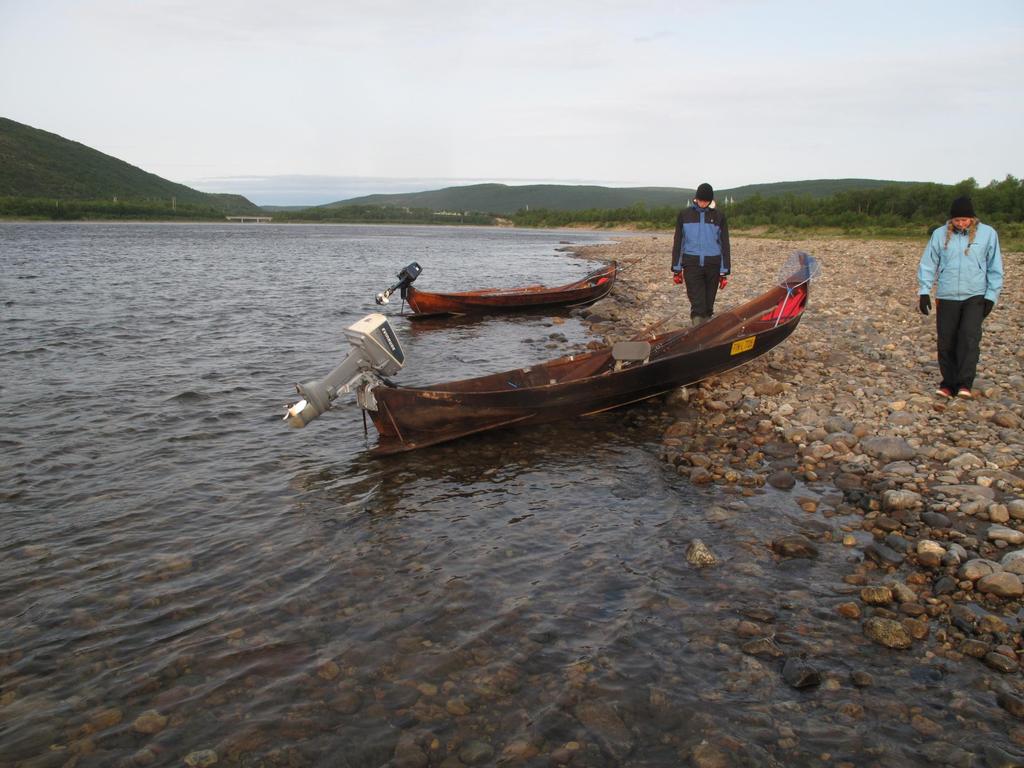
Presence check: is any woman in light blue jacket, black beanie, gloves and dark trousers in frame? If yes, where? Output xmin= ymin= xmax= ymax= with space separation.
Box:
xmin=918 ymin=197 xmax=1002 ymax=397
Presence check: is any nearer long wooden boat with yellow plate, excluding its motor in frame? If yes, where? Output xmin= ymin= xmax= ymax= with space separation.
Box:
xmin=369 ymin=253 xmax=817 ymax=454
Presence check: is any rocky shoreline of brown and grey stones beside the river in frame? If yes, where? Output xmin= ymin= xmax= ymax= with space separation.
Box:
xmin=572 ymin=233 xmax=1024 ymax=684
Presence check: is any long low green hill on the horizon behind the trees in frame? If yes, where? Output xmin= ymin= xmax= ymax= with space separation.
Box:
xmin=318 ymin=179 xmax=911 ymax=215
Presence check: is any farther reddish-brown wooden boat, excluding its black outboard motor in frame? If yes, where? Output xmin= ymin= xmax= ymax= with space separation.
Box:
xmin=402 ymin=261 xmax=618 ymax=319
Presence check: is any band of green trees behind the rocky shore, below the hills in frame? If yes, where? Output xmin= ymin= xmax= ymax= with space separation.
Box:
xmin=512 ymin=176 xmax=1024 ymax=233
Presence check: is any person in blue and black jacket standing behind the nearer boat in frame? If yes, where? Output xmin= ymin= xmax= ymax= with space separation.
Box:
xmin=672 ymin=182 xmax=732 ymax=326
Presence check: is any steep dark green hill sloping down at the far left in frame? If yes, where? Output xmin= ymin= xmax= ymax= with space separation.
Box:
xmin=0 ymin=118 xmax=260 ymax=214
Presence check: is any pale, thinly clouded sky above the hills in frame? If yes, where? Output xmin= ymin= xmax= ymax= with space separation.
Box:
xmin=0 ymin=0 xmax=1024 ymax=205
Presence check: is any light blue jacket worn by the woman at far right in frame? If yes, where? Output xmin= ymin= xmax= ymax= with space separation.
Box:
xmin=918 ymin=222 xmax=1002 ymax=304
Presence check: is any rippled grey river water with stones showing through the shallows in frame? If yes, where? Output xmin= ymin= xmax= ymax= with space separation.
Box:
xmin=0 ymin=223 xmax=1010 ymax=768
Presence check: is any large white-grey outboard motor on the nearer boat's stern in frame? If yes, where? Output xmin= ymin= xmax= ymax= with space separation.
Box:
xmin=284 ymin=313 xmax=406 ymax=427
